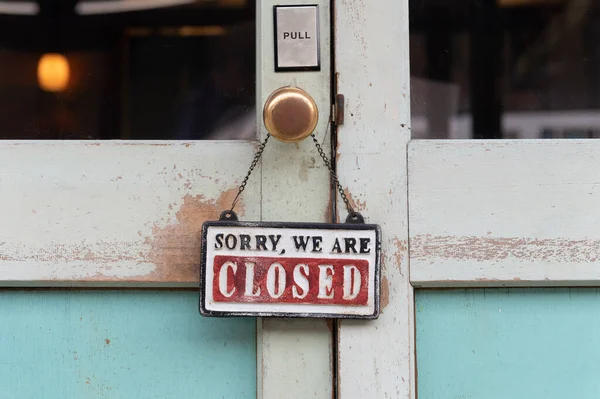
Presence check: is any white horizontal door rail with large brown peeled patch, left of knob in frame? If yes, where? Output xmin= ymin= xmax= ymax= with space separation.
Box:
xmin=0 ymin=141 xmax=260 ymax=286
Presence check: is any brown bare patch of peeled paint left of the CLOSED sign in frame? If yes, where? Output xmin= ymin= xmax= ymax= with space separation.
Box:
xmin=140 ymin=188 xmax=243 ymax=282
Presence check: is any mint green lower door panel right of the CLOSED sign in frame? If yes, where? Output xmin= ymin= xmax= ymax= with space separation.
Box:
xmin=416 ymin=288 xmax=600 ymax=399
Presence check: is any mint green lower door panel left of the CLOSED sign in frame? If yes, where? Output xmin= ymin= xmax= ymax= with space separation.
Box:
xmin=0 ymin=290 xmax=256 ymax=399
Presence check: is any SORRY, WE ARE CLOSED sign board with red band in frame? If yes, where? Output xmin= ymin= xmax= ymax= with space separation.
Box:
xmin=200 ymin=221 xmax=381 ymax=319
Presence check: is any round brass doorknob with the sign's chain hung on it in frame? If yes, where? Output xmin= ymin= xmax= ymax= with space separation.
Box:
xmin=263 ymin=87 xmax=319 ymax=143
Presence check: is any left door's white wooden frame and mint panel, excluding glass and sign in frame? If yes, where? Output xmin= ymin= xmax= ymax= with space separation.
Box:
xmin=0 ymin=1 xmax=333 ymax=398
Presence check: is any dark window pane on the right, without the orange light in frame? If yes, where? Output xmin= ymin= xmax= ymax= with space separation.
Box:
xmin=410 ymin=0 xmax=600 ymax=139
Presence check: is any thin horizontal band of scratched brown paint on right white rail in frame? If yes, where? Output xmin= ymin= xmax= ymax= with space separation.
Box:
xmin=411 ymin=234 xmax=600 ymax=263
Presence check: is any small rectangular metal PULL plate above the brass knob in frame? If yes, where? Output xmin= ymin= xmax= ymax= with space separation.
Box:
xmin=273 ymin=5 xmax=321 ymax=72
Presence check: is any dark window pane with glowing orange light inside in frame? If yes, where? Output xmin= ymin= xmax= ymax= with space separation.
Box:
xmin=0 ymin=0 xmax=256 ymax=140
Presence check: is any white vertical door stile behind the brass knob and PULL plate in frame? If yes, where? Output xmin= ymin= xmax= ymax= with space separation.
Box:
xmin=257 ymin=0 xmax=333 ymax=399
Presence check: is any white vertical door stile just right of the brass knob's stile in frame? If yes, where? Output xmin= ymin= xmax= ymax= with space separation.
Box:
xmin=335 ymin=0 xmax=415 ymax=399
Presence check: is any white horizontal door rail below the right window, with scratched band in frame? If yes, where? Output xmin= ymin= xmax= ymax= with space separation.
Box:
xmin=409 ymin=140 xmax=600 ymax=287
